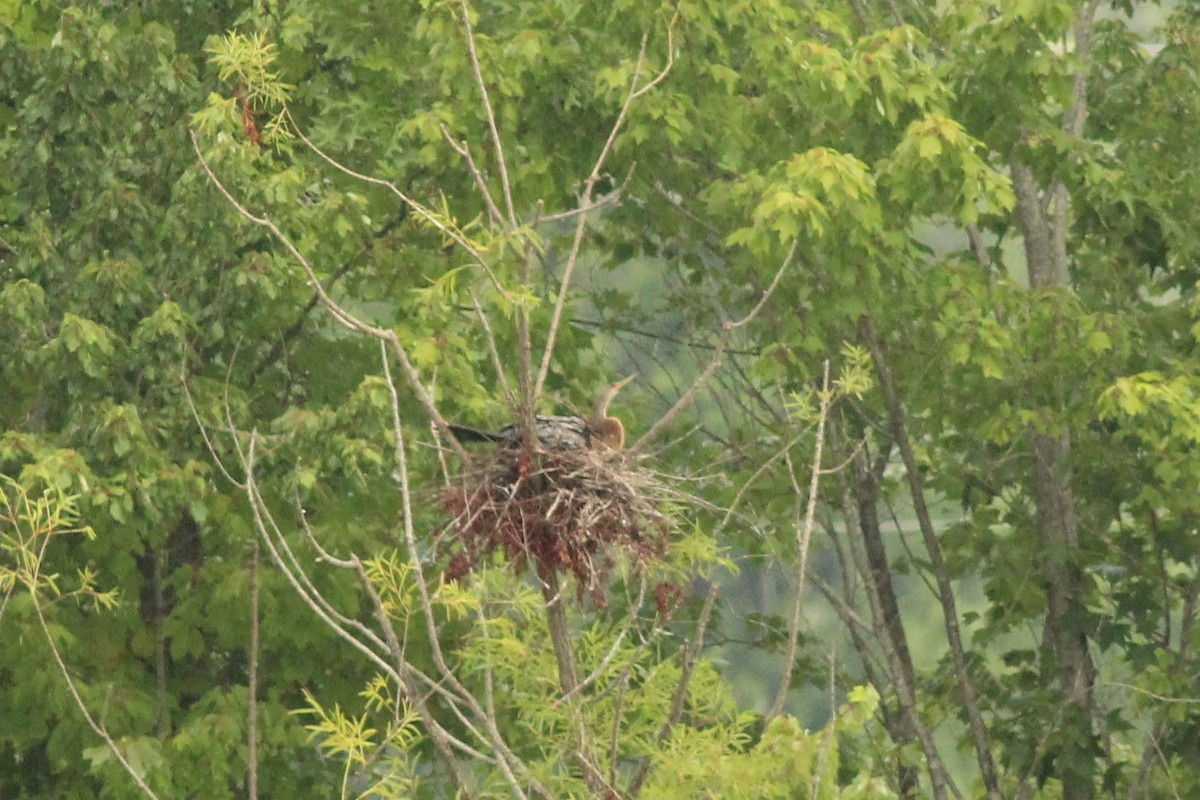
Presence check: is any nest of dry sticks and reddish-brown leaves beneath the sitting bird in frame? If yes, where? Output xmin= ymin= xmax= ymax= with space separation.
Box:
xmin=443 ymin=447 xmax=676 ymax=607
